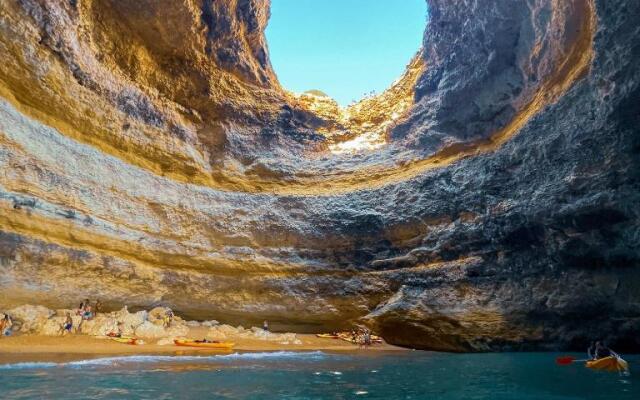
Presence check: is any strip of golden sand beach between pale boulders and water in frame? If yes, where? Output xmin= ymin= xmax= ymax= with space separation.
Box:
xmin=0 ymin=328 xmax=406 ymax=364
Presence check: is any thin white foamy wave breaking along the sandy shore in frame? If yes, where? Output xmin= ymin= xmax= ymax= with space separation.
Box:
xmin=0 ymin=351 xmax=327 ymax=370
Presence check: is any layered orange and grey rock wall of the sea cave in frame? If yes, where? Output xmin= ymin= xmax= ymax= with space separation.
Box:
xmin=0 ymin=0 xmax=640 ymax=351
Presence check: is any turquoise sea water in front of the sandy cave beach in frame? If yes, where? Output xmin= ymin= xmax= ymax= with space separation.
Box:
xmin=0 ymin=352 xmax=640 ymax=400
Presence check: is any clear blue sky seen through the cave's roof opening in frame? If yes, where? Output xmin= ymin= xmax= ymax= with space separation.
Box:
xmin=266 ymin=0 xmax=427 ymax=105
